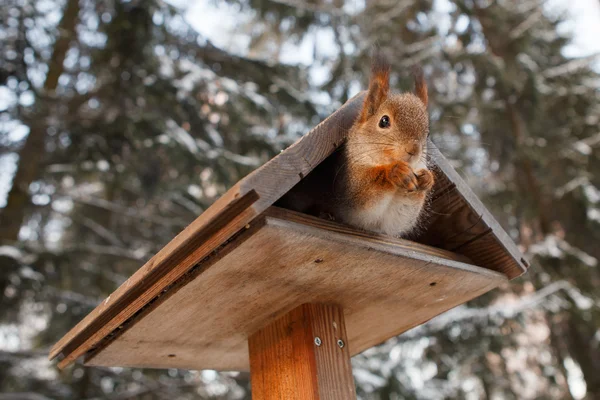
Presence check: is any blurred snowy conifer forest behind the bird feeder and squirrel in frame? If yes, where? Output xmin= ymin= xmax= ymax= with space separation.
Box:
xmin=0 ymin=0 xmax=600 ymax=400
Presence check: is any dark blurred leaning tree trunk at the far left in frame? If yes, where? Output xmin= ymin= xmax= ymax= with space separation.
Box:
xmin=0 ymin=0 xmax=79 ymax=242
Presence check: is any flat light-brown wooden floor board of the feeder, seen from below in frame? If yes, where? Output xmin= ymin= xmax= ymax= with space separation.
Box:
xmin=86 ymin=209 xmax=506 ymax=370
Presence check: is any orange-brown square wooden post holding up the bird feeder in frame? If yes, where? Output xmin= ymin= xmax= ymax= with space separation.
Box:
xmin=248 ymin=304 xmax=356 ymax=400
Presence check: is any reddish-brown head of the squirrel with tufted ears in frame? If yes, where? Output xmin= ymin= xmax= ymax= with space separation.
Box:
xmin=346 ymin=54 xmax=429 ymax=166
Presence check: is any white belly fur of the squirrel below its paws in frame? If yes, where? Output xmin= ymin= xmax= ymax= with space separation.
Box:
xmin=347 ymin=194 xmax=424 ymax=236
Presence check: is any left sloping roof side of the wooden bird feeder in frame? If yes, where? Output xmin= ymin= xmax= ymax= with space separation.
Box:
xmin=49 ymin=92 xmax=364 ymax=368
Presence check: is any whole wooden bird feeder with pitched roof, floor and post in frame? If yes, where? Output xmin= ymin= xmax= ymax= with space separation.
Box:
xmin=50 ymin=93 xmax=529 ymax=400
